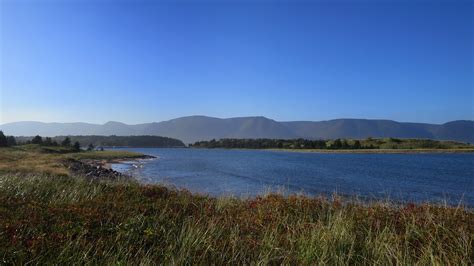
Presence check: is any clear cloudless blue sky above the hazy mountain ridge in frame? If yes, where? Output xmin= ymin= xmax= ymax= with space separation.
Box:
xmin=0 ymin=0 xmax=474 ymax=124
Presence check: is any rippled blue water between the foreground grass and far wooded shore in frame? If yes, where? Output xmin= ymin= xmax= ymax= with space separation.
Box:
xmin=109 ymin=148 xmax=474 ymax=206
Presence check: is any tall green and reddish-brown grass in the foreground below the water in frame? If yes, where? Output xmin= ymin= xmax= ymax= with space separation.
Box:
xmin=0 ymin=174 xmax=474 ymax=265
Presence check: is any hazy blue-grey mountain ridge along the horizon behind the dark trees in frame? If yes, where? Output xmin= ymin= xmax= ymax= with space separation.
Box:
xmin=0 ymin=116 xmax=474 ymax=143
